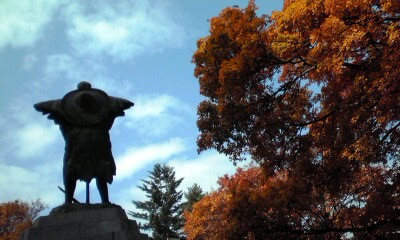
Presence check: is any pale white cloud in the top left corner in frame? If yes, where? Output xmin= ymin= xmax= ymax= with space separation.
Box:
xmin=0 ymin=0 xmax=64 ymax=49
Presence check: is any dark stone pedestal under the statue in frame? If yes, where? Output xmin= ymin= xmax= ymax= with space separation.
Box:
xmin=21 ymin=203 xmax=149 ymax=240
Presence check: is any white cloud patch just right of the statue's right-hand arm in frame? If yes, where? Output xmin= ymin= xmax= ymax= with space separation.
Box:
xmin=125 ymin=94 xmax=194 ymax=136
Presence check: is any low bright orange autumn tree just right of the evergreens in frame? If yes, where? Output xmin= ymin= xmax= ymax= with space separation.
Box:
xmin=185 ymin=167 xmax=286 ymax=240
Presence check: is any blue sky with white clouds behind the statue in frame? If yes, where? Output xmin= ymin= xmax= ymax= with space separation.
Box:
xmin=0 ymin=0 xmax=283 ymax=213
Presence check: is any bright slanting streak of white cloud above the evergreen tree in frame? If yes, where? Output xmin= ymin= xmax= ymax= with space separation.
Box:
xmin=116 ymin=138 xmax=185 ymax=181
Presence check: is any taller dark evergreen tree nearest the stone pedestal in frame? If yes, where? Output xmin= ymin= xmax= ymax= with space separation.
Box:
xmin=129 ymin=164 xmax=183 ymax=240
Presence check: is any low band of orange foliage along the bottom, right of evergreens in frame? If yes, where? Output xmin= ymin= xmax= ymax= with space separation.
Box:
xmin=184 ymin=167 xmax=400 ymax=240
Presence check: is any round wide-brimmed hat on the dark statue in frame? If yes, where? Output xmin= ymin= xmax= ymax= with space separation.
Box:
xmin=61 ymin=82 xmax=111 ymax=126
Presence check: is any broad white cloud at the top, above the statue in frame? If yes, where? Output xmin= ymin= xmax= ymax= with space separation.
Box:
xmin=66 ymin=0 xmax=184 ymax=60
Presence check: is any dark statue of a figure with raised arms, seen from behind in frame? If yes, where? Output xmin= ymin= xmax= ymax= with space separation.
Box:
xmin=34 ymin=82 xmax=133 ymax=203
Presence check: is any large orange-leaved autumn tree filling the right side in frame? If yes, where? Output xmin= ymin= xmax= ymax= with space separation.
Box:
xmin=189 ymin=0 xmax=400 ymax=239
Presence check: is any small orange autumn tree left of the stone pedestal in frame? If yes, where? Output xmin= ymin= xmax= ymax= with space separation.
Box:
xmin=0 ymin=200 xmax=46 ymax=240
